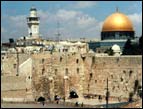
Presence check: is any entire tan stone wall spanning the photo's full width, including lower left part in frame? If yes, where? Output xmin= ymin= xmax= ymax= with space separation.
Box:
xmin=1 ymin=52 xmax=142 ymax=100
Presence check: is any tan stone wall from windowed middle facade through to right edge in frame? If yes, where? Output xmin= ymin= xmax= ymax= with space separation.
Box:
xmin=32 ymin=53 xmax=142 ymax=98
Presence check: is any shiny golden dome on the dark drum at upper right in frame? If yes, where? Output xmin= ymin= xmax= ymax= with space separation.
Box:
xmin=102 ymin=12 xmax=134 ymax=32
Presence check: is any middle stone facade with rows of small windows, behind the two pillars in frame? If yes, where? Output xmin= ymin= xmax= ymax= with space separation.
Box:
xmin=33 ymin=53 xmax=84 ymax=97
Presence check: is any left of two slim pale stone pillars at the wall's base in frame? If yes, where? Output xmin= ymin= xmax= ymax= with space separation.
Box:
xmin=49 ymin=77 xmax=55 ymax=101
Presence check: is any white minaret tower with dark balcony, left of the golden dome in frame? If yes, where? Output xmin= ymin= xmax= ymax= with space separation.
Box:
xmin=27 ymin=7 xmax=40 ymax=39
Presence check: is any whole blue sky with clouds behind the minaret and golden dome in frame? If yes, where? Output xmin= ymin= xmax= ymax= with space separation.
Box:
xmin=1 ymin=1 xmax=142 ymax=41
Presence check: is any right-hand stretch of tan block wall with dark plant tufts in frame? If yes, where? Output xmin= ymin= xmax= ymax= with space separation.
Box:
xmin=84 ymin=56 xmax=142 ymax=97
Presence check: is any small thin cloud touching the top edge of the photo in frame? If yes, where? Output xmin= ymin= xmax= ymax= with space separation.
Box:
xmin=74 ymin=1 xmax=97 ymax=9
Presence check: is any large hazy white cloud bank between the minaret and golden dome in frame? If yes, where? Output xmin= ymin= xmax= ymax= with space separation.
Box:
xmin=38 ymin=9 xmax=100 ymax=39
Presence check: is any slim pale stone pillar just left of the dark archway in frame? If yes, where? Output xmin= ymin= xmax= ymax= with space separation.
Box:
xmin=63 ymin=76 xmax=69 ymax=100
